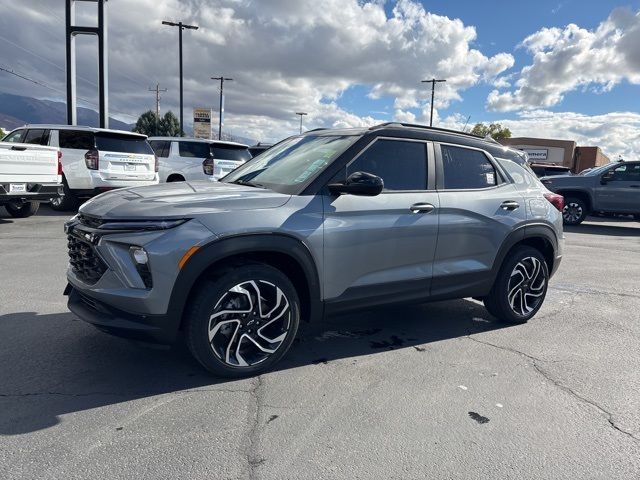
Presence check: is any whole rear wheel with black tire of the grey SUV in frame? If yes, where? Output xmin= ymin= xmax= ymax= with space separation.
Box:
xmin=484 ymin=246 xmax=549 ymax=323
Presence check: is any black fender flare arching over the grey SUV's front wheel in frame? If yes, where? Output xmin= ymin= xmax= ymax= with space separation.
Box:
xmin=162 ymin=233 xmax=323 ymax=331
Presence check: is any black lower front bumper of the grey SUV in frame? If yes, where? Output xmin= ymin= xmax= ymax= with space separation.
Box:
xmin=64 ymin=284 xmax=178 ymax=344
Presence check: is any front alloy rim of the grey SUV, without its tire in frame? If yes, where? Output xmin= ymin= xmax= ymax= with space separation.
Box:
xmin=208 ymin=280 xmax=291 ymax=367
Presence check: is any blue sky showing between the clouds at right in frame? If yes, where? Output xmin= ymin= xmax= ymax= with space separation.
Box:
xmin=338 ymin=0 xmax=640 ymax=125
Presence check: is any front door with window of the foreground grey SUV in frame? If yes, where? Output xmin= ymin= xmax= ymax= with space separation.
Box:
xmin=324 ymin=138 xmax=438 ymax=303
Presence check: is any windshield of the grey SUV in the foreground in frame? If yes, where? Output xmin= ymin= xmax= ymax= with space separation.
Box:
xmin=221 ymin=135 xmax=360 ymax=193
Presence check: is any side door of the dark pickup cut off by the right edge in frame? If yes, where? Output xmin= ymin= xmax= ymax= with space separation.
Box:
xmin=595 ymin=162 xmax=640 ymax=213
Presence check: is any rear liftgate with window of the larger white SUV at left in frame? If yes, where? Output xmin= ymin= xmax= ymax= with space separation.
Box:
xmin=95 ymin=132 xmax=156 ymax=181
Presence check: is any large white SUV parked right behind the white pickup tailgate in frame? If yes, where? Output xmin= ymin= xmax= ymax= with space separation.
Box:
xmin=4 ymin=125 xmax=158 ymax=210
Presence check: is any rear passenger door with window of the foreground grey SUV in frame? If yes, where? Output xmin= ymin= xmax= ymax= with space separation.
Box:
xmin=431 ymin=144 xmax=526 ymax=295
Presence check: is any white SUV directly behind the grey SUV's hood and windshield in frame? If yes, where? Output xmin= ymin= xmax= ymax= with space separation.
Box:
xmin=149 ymin=137 xmax=251 ymax=182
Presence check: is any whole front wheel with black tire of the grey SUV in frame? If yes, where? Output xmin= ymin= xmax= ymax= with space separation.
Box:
xmin=184 ymin=263 xmax=300 ymax=378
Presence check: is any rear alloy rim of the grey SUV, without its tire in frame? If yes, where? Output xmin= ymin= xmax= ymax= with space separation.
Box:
xmin=507 ymin=257 xmax=547 ymax=317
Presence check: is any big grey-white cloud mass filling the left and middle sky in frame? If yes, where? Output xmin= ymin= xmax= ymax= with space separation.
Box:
xmin=0 ymin=0 xmax=513 ymax=140
